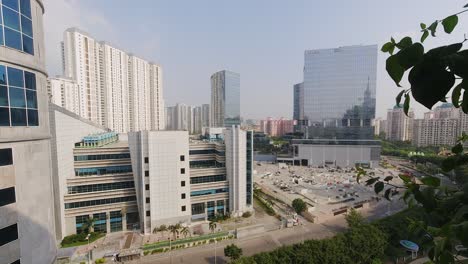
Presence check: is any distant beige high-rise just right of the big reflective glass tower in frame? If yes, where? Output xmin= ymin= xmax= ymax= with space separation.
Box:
xmin=385 ymin=106 xmax=414 ymax=141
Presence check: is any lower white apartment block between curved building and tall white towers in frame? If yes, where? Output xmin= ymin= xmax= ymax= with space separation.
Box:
xmin=47 ymin=76 xmax=80 ymax=115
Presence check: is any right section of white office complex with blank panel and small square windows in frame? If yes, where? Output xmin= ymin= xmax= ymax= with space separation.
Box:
xmin=129 ymin=127 xmax=253 ymax=234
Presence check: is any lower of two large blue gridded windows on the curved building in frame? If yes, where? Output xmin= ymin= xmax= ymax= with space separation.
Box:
xmin=0 ymin=65 xmax=39 ymax=126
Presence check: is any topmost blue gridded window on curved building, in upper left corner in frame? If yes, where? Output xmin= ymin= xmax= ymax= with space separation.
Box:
xmin=0 ymin=0 xmax=34 ymax=55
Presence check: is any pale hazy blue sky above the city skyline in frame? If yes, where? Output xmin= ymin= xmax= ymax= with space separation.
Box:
xmin=44 ymin=0 xmax=468 ymax=119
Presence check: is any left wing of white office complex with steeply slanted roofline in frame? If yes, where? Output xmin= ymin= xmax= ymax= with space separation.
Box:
xmin=49 ymin=104 xmax=139 ymax=240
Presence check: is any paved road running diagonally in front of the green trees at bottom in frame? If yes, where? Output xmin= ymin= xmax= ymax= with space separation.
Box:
xmin=127 ymin=201 xmax=403 ymax=264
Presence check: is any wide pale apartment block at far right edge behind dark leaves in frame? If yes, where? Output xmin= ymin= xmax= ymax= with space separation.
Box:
xmin=413 ymin=103 xmax=468 ymax=147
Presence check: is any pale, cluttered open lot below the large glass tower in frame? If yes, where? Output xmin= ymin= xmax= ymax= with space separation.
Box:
xmin=254 ymin=162 xmax=402 ymax=220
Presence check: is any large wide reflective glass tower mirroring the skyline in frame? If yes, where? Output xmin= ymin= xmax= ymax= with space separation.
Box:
xmin=304 ymin=45 xmax=377 ymax=140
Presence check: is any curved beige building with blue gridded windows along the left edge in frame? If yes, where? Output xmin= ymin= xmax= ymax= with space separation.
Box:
xmin=0 ymin=0 xmax=57 ymax=264
